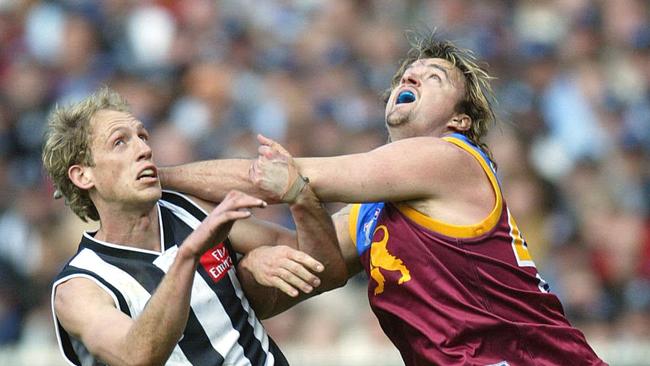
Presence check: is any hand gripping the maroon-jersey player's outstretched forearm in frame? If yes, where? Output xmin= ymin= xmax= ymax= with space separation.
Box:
xmin=249 ymin=135 xmax=305 ymax=203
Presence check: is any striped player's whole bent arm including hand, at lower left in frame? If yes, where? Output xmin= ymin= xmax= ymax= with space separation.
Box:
xmin=54 ymin=192 xmax=264 ymax=365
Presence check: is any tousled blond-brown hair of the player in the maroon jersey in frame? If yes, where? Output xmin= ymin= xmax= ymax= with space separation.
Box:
xmin=384 ymin=30 xmax=497 ymax=158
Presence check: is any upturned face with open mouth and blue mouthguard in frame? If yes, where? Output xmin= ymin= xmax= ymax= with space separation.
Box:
xmin=386 ymin=58 xmax=465 ymax=140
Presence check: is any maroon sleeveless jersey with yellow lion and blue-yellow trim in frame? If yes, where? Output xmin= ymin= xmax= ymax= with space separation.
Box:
xmin=350 ymin=134 xmax=605 ymax=366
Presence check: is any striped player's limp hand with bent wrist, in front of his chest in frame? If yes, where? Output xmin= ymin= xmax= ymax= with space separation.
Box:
xmin=183 ymin=191 xmax=266 ymax=257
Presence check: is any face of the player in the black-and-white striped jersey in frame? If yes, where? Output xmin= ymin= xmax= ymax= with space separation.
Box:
xmin=86 ymin=110 xmax=161 ymax=209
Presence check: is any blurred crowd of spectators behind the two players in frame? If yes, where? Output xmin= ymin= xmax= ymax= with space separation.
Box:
xmin=0 ymin=0 xmax=650 ymax=365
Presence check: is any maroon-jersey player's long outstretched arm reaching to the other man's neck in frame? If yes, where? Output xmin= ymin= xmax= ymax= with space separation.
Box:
xmin=161 ymin=135 xmax=466 ymax=203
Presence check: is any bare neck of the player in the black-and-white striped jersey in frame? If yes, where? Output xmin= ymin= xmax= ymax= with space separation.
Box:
xmin=95 ymin=206 xmax=161 ymax=251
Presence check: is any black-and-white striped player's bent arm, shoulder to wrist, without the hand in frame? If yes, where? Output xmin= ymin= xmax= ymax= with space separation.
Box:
xmin=54 ymin=246 xmax=198 ymax=365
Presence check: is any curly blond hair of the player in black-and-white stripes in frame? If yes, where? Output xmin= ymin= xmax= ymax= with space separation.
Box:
xmin=42 ymin=87 xmax=130 ymax=221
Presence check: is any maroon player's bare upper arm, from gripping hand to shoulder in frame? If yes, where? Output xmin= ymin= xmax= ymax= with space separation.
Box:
xmin=296 ymin=137 xmax=468 ymax=203
